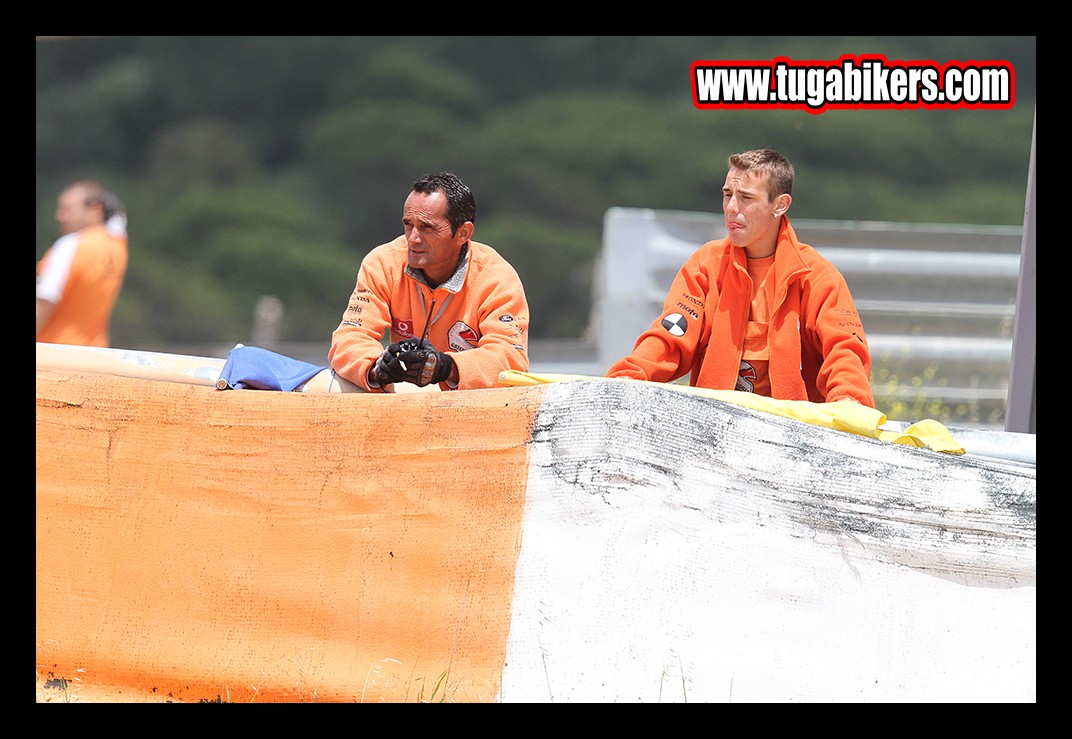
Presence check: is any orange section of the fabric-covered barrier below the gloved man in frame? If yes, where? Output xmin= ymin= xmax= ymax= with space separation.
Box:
xmin=36 ymin=369 xmax=542 ymax=703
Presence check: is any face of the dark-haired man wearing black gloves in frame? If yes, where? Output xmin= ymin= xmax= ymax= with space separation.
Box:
xmin=402 ymin=192 xmax=472 ymax=282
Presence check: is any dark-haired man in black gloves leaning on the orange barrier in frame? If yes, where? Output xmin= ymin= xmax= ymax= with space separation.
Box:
xmin=328 ymin=172 xmax=528 ymax=391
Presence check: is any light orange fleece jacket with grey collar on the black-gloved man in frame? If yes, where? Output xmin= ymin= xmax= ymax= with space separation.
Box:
xmin=328 ymin=236 xmax=528 ymax=390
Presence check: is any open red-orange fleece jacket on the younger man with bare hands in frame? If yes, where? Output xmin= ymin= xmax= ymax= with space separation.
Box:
xmin=607 ymin=218 xmax=875 ymax=408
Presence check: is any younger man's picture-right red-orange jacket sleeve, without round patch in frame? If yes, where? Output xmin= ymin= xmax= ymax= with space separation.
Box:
xmin=804 ymin=268 xmax=875 ymax=408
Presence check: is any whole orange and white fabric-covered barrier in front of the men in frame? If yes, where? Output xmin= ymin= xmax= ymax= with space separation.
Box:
xmin=35 ymin=367 xmax=1037 ymax=703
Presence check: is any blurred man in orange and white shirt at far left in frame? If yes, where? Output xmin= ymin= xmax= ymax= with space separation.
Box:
xmin=38 ymin=179 xmax=128 ymax=346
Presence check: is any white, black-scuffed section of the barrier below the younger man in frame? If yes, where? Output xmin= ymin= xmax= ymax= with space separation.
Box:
xmin=502 ymin=382 xmax=1037 ymax=703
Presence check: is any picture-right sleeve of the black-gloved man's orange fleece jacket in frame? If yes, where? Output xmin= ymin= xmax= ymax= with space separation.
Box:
xmin=440 ymin=263 xmax=528 ymax=390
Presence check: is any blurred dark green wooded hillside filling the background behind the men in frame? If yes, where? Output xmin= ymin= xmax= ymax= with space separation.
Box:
xmin=36 ymin=36 xmax=1036 ymax=350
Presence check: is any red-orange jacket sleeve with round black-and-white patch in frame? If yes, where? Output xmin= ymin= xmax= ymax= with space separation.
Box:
xmin=607 ymin=251 xmax=717 ymax=382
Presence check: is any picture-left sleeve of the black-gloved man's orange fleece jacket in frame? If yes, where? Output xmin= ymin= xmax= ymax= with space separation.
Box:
xmin=328 ymin=253 xmax=390 ymax=391
